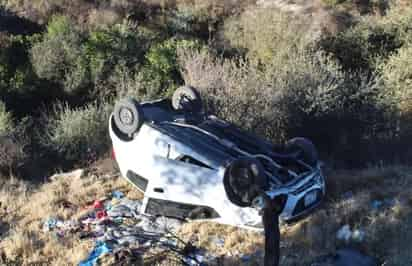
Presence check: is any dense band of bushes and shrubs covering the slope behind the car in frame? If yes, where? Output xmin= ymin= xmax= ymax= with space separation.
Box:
xmin=0 ymin=0 xmax=412 ymax=179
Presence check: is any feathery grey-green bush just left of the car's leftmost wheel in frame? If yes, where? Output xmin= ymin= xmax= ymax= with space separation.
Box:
xmin=41 ymin=104 xmax=111 ymax=161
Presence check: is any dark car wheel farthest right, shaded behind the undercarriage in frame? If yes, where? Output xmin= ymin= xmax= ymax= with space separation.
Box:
xmin=286 ymin=137 xmax=319 ymax=166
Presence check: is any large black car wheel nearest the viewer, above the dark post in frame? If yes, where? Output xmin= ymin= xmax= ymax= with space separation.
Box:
xmin=223 ymin=158 xmax=269 ymax=207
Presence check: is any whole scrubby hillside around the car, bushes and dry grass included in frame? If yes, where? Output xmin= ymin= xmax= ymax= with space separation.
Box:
xmin=0 ymin=0 xmax=412 ymax=266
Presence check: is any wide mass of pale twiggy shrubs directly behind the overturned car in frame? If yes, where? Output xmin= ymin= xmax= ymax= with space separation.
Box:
xmin=180 ymin=46 xmax=378 ymax=155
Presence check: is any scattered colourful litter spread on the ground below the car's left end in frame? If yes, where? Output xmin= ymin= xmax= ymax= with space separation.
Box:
xmin=43 ymin=191 xmax=208 ymax=266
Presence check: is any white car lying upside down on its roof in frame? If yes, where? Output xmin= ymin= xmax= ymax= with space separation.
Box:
xmin=109 ymin=87 xmax=325 ymax=228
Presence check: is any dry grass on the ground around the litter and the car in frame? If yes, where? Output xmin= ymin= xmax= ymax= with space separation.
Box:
xmin=0 ymin=164 xmax=412 ymax=266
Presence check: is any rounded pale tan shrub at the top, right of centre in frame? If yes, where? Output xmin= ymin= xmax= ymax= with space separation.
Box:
xmin=223 ymin=8 xmax=312 ymax=63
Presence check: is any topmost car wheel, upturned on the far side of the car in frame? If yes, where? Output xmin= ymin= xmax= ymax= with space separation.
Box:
xmin=172 ymin=86 xmax=203 ymax=113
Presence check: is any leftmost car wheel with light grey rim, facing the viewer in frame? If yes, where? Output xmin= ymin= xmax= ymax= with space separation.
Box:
xmin=113 ymin=98 xmax=144 ymax=137
